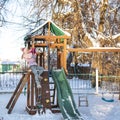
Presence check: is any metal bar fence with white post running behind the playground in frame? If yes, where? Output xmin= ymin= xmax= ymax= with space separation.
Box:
xmin=0 ymin=72 xmax=120 ymax=93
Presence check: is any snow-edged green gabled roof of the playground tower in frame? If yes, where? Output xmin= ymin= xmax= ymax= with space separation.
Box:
xmin=24 ymin=20 xmax=70 ymax=40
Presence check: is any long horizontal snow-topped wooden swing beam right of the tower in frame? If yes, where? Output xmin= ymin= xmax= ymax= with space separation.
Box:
xmin=67 ymin=47 xmax=120 ymax=52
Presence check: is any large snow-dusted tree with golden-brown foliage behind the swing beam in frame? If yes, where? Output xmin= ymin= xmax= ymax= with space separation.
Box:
xmin=24 ymin=0 xmax=120 ymax=72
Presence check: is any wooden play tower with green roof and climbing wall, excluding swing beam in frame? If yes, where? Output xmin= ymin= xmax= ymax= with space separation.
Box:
xmin=6 ymin=22 xmax=70 ymax=115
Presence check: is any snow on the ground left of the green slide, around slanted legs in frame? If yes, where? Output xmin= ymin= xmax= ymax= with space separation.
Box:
xmin=0 ymin=94 xmax=63 ymax=120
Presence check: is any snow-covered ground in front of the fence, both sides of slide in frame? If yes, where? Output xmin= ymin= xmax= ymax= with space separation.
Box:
xmin=0 ymin=93 xmax=120 ymax=120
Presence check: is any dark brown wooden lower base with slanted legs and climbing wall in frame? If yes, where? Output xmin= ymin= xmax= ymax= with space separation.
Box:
xmin=6 ymin=71 xmax=60 ymax=115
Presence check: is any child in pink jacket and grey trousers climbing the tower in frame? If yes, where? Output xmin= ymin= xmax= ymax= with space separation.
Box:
xmin=21 ymin=47 xmax=44 ymax=88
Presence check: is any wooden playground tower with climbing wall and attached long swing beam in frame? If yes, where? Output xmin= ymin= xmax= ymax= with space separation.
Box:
xmin=6 ymin=21 xmax=120 ymax=116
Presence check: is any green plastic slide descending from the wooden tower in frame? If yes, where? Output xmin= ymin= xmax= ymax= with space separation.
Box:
xmin=51 ymin=69 xmax=83 ymax=120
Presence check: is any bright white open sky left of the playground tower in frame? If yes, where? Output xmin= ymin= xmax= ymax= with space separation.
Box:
xmin=0 ymin=0 xmax=29 ymax=60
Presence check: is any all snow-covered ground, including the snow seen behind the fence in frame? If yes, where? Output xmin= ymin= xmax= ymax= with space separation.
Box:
xmin=0 ymin=73 xmax=120 ymax=120
